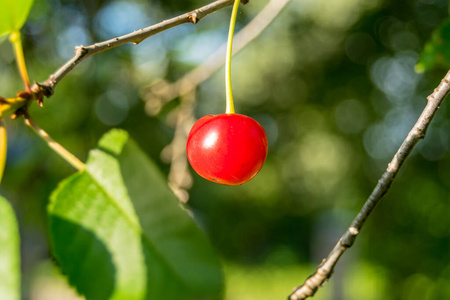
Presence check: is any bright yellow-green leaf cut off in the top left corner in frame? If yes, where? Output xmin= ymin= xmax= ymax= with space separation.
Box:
xmin=0 ymin=0 xmax=33 ymax=36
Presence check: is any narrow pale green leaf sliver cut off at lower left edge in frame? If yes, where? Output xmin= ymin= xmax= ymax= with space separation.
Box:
xmin=0 ymin=196 xmax=20 ymax=300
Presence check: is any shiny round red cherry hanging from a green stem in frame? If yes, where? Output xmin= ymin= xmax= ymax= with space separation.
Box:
xmin=186 ymin=114 xmax=268 ymax=185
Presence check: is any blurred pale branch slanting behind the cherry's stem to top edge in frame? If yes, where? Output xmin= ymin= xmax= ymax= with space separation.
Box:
xmin=143 ymin=0 xmax=290 ymax=115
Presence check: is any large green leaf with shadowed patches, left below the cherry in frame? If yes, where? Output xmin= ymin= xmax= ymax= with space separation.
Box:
xmin=49 ymin=130 xmax=223 ymax=300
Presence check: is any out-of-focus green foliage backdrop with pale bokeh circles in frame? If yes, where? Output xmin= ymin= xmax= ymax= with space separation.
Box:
xmin=0 ymin=0 xmax=450 ymax=300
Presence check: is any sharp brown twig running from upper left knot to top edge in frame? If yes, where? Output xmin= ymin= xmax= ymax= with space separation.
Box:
xmin=34 ymin=0 xmax=248 ymax=96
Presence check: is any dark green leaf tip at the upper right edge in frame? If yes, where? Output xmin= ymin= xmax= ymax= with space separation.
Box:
xmin=415 ymin=19 xmax=450 ymax=73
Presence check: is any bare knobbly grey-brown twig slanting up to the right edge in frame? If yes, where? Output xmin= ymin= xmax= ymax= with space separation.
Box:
xmin=288 ymin=71 xmax=450 ymax=300
